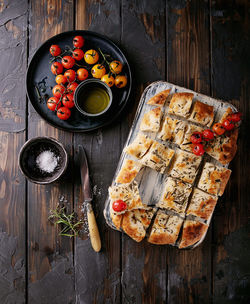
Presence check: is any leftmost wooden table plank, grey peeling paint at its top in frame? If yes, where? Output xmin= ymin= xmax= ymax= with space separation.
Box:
xmin=0 ymin=1 xmax=28 ymax=303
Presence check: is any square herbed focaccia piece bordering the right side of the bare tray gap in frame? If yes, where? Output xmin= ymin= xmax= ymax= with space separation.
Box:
xmin=156 ymin=177 xmax=192 ymax=215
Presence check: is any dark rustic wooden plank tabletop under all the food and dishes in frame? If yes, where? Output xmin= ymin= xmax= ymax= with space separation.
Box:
xmin=0 ymin=0 xmax=250 ymax=304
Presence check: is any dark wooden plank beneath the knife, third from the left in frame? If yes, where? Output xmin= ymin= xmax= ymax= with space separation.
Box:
xmin=74 ymin=1 xmax=123 ymax=303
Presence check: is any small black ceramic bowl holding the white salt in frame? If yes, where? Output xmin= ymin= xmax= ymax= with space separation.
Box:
xmin=18 ymin=137 xmax=68 ymax=184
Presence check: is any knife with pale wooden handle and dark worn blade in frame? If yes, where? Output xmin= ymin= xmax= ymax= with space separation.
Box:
xmin=79 ymin=146 xmax=101 ymax=252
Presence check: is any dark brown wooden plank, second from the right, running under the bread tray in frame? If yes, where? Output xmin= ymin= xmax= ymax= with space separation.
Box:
xmin=168 ymin=1 xmax=211 ymax=304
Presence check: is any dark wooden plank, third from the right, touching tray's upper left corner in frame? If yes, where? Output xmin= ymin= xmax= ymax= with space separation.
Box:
xmin=121 ymin=0 xmax=168 ymax=303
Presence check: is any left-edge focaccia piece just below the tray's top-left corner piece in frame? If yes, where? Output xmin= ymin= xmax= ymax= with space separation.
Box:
xmin=140 ymin=107 xmax=162 ymax=132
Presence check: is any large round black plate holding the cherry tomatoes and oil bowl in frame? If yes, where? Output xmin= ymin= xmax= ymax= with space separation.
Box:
xmin=26 ymin=30 xmax=132 ymax=132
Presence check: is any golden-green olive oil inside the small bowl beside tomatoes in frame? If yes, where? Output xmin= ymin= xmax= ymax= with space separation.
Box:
xmin=79 ymin=86 xmax=110 ymax=114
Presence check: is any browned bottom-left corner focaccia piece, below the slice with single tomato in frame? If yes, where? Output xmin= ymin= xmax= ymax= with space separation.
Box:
xmin=122 ymin=208 xmax=156 ymax=242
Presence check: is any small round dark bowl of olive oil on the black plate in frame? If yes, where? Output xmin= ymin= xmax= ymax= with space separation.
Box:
xmin=74 ymin=78 xmax=113 ymax=117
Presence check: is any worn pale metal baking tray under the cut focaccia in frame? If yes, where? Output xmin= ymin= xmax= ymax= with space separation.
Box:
xmin=103 ymin=81 xmax=237 ymax=248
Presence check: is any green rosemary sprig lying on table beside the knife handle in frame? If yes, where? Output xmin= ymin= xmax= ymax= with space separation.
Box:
xmin=48 ymin=206 xmax=83 ymax=237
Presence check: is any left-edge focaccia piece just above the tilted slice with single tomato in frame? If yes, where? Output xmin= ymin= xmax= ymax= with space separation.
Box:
xmin=115 ymin=159 xmax=142 ymax=184
